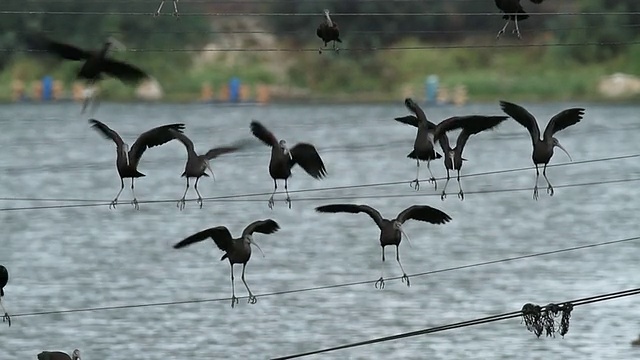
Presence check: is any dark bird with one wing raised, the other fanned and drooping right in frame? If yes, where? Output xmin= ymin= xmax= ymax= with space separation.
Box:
xmin=251 ymin=120 xmax=327 ymax=209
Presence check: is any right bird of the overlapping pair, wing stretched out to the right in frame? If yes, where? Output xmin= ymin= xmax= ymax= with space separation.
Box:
xmin=439 ymin=115 xmax=509 ymax=200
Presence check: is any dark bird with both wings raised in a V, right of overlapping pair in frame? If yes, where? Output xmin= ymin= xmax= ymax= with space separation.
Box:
xmin=500 ymin=101 xmax=585 ymax=200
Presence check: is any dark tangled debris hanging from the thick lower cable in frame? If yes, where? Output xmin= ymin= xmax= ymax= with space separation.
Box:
xmin=521 ymin=302 xmax=573 ymax=338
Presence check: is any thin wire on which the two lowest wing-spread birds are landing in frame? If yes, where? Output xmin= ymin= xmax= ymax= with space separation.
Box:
xmin=11 ymin=236 xmax=640 ymax=318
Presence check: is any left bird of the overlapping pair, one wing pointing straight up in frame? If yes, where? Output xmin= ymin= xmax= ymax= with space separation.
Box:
xmin=395 ymin=98 xmax=490 ymax=190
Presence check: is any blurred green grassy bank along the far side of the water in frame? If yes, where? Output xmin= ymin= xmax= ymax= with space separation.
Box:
xmin=0 ymin=40 xmax=640 ymax=101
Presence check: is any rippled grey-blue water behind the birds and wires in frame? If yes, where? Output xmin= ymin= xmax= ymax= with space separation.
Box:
xmin=0 ymin=101 xmax=640 ymax=360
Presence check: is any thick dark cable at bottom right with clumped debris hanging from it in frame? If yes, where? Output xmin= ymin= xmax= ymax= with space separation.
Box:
xmin=271 ymin=288 xmax=640 ymax=360
